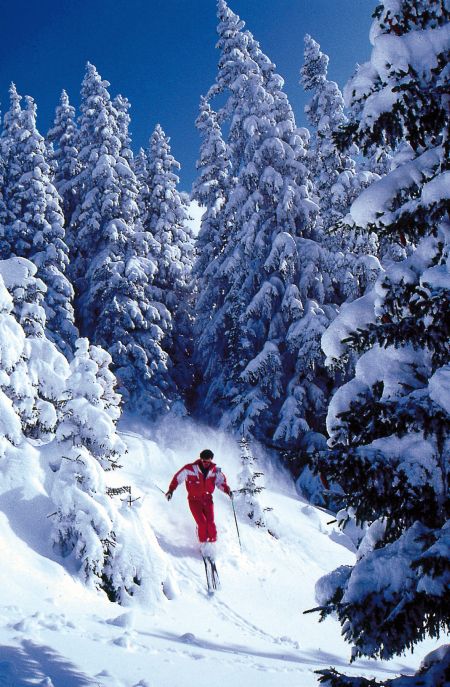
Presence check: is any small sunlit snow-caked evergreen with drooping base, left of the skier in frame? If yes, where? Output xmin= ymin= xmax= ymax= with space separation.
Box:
xmin=52 ymin=339 xmax=171 ymax=604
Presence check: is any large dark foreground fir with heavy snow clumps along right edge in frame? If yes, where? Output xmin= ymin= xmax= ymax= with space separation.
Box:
xmin=312 ymin=0 xmax=450 ymax=687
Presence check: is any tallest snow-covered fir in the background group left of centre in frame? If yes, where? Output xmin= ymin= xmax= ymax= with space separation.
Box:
xmin=68 ymin=64 xmax=178 ymax=416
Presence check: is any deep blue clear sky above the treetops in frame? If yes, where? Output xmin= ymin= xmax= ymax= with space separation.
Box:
xmin=0 ymin=0 xmax=376 ymax=190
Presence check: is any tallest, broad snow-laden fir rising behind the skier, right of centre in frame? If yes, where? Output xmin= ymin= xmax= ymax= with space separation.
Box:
xmin=196 ymin=0 xmax=335 ymax=452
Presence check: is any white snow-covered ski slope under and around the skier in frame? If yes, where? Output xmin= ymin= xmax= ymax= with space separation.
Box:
xmin=0 ymin=419 xmax=439 ymax=687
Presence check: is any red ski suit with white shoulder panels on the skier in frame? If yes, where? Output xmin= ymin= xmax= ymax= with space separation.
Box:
xmin=169 ymin=459 xmax=231 ymax=542
